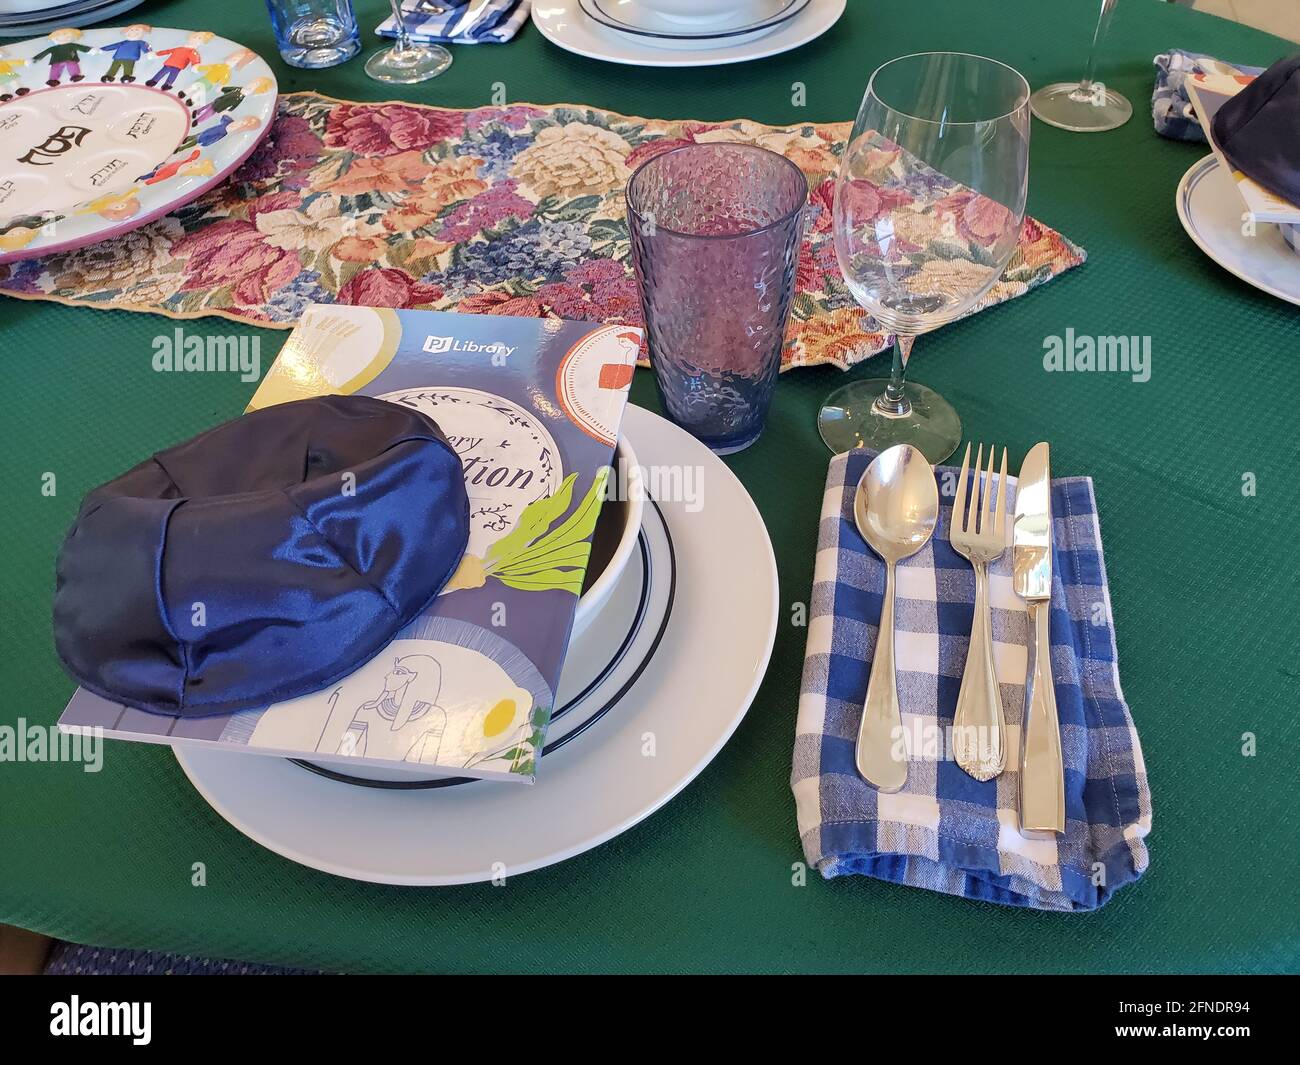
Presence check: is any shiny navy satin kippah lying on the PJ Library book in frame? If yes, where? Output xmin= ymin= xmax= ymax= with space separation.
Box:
xmin=55 ymin=395 xmax=469 ymax=717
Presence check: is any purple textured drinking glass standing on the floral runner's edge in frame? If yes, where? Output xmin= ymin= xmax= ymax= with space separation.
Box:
xmin=627 ymin=143 xmax=809 ymax=455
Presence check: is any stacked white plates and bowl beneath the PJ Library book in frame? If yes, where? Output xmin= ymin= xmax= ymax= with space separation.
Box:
xmin=176 ymin=406 xmax=779 ymax=886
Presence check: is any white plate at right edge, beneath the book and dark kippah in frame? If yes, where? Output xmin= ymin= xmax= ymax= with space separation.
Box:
xmin=1174 ymin=155 xmax=1300 ymax=304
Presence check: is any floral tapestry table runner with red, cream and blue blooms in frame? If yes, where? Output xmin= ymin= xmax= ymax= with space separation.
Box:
xmin=0 ymin=92 xmax=1086 ymax=369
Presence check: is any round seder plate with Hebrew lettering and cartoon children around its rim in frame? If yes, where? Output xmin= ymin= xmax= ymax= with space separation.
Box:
xmin=0 ymin=25 xmax=276 ymax=263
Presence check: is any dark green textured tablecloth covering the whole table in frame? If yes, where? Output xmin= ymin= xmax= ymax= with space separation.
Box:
xmin=0 ymin=0 xmax=1300 ymax=971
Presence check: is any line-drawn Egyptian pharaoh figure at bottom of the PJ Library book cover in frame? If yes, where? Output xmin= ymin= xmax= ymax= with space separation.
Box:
xmin=338 ymin=654 xmax=447 ymax=762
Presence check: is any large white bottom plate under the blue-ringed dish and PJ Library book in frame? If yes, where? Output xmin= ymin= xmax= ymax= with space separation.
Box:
xmin=176 ymin=407 xmax=779 ymax=886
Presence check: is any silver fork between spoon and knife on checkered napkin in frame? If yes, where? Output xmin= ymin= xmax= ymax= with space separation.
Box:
xmin=949 ymin=443 xmax=1006 ymax=780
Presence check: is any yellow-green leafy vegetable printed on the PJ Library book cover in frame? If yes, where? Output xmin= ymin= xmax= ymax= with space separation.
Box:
xmin=446 ymin=467 xmax=610 ymax=596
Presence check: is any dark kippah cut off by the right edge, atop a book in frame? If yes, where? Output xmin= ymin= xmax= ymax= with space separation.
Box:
xmin=1213 ymin=56 xmax=1300 ymax=204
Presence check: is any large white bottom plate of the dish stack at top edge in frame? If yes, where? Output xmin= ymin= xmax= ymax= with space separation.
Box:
xmin=533 ymin=0 xmax=846 ymax=66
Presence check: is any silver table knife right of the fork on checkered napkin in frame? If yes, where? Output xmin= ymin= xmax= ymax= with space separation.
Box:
xmin=1011 ymin=442 xmax=1065 ymax=839
